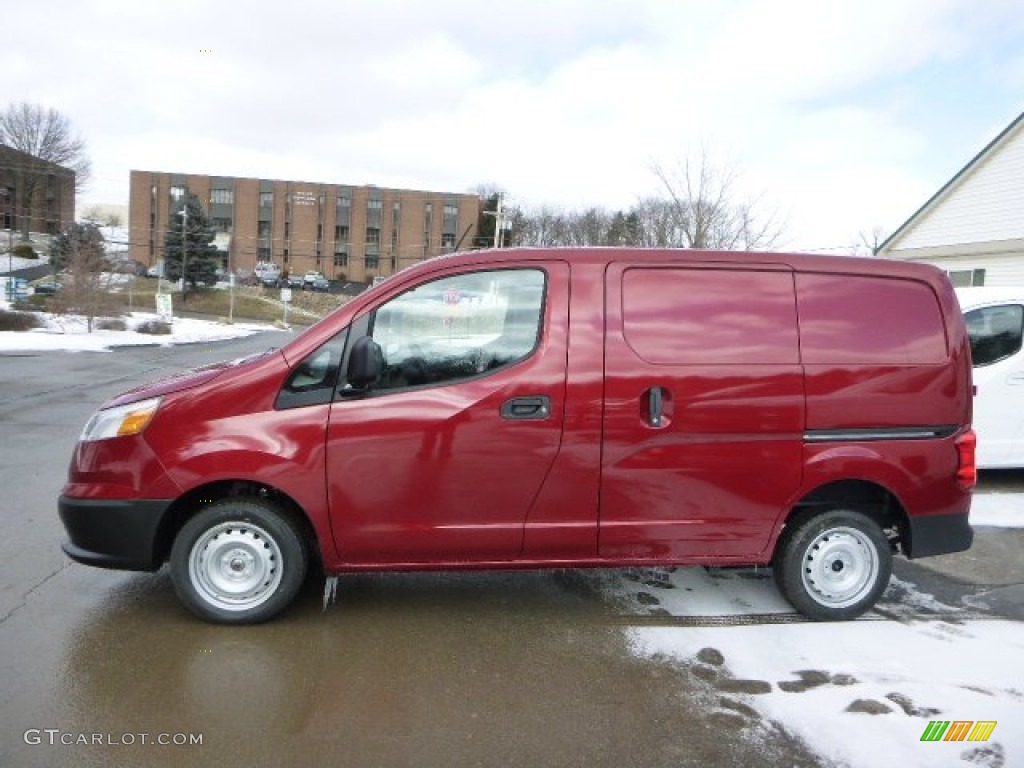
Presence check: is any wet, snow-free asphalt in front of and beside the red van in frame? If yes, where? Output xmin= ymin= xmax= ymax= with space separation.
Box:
xmin=0 ymin=334 xmax=1020 ymax=766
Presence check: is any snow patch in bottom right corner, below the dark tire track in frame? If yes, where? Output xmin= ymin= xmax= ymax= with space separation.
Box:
xmin=632 ymin=621 xmax=1024 ymax=768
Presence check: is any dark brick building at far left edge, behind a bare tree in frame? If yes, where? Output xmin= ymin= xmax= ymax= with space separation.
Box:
xmin=0 ymin=144 xmax=75 ymax=234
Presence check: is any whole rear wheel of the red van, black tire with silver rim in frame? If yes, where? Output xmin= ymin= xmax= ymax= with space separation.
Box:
xmin=774 ymin=509 xmax=893 ymax=622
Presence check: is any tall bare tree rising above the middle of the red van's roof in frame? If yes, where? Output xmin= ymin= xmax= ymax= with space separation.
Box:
xmin=652 ymin=148 xmax=782 ymax=251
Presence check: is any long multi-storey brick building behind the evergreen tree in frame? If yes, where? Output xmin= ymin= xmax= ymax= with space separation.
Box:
xmin=129 ymin=171 xmax=481 ymax=282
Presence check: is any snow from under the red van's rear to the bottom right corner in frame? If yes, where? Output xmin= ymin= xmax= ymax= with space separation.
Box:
xmin=604 ymin=567 xmax=1024 ymax=768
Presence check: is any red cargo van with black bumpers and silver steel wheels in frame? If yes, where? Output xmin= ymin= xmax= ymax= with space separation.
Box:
xmin=59 ymin=249 xmax=975 ymax=624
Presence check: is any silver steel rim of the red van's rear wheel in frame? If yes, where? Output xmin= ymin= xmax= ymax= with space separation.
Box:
xmin=802 ymin=527 xmax=879 ymax=608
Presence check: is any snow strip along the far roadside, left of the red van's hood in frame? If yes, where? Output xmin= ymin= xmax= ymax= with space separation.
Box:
xmin=0 ymin=301 xmax=284 ymax=352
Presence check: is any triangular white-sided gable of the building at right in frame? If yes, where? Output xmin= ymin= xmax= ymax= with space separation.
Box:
xmin=890 ymin=123 xmax=1024 ymax=249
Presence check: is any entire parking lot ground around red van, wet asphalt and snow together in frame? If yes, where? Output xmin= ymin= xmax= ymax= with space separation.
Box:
xmin=0 ymin=334 xmax=1024 ymax=766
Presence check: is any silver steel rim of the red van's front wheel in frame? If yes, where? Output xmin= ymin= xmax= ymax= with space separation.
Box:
xmin=188 ymin=522 xmax=282 ymax=610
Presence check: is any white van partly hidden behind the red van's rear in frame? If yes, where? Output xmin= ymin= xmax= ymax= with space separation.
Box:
xmin=956 ymin=287 xmax=1024 ymax=469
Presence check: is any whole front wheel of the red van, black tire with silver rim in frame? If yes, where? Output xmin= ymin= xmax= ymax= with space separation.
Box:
xmin=171 ymin=499 xmax=309 ymax=624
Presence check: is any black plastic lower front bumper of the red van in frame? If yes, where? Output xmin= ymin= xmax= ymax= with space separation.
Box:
xmin=57 ymin=496 xmax=171 ymax=570
